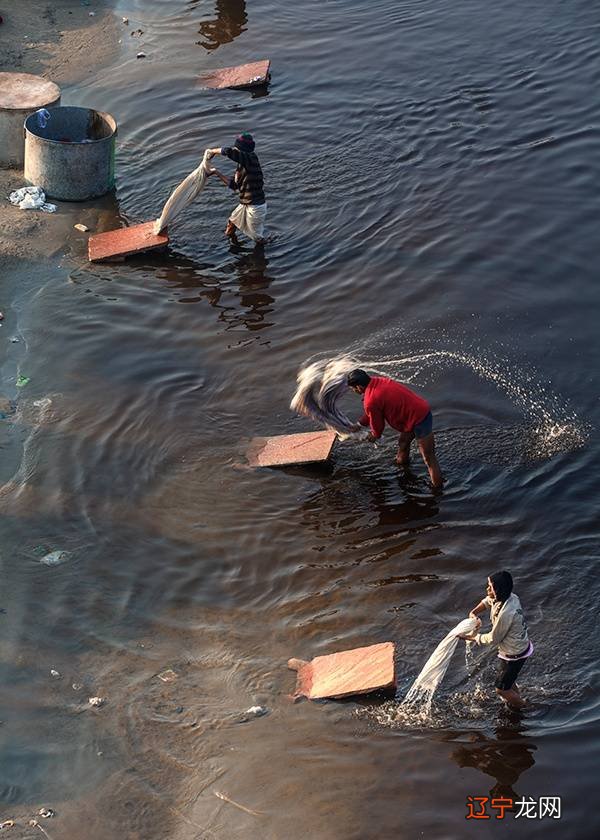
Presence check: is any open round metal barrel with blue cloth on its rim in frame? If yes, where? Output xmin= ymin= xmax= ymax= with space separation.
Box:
xmin=24 ymin=106 xmax=117 ymax=201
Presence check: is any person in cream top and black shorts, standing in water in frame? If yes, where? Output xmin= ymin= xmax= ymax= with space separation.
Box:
xmin=461 ymin=571 xmax=533 ymax=709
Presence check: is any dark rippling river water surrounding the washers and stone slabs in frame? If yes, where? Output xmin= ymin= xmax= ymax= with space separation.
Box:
xmin=0 ymin=0 xmax=600 ymax=840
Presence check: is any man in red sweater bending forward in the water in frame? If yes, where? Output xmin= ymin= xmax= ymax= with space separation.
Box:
xmin=347 ymin=368 xmax=443 ymax=489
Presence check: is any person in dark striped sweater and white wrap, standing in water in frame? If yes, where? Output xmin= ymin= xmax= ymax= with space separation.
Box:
xmin=208 ymin=132 xmax=267 ymax=245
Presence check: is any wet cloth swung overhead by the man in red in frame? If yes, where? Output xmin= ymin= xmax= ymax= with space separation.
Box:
xmin=290 ymin=356 xmax=366 ymax=437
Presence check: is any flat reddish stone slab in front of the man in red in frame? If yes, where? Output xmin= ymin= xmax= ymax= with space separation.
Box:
xmin=246 ymin=431 xmax=337 ymax=467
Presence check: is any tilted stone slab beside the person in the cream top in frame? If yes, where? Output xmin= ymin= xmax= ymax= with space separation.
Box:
xmin=288 ymin=642 xmax=396 ymax=700
